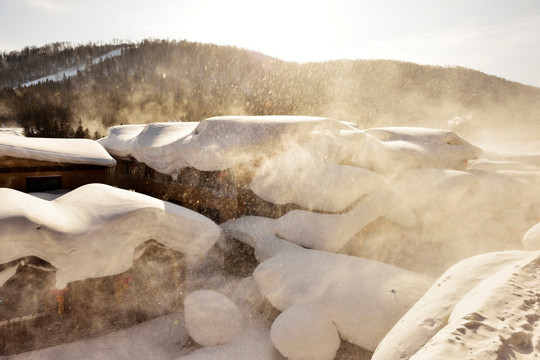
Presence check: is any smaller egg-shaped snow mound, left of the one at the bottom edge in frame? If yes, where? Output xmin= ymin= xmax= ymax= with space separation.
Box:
xmin=184 ymin=290 xmax=244 ymax=346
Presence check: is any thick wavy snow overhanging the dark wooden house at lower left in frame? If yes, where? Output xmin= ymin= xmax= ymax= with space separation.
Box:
xmin=0 ymin=184 xmax=221 ymax=288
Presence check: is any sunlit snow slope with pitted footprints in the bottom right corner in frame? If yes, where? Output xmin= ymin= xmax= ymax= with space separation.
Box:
xmin=373 ymin=251 xmax=540 ymax=360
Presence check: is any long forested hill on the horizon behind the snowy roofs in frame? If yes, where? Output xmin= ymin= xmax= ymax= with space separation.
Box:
xmin=0 ymin=40 xmax=540 ymax=136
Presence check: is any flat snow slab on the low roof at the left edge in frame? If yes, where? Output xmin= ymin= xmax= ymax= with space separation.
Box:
xmin=0 ymin=132 xmax=116 ymax=167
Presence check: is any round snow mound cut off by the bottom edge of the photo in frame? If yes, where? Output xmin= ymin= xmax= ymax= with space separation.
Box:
xmin=270 ymin=304 xmax=341 ymax=360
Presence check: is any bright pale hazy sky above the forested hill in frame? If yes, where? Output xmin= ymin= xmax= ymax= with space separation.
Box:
xmin=0 ymin=0 xmax=540 ymax=87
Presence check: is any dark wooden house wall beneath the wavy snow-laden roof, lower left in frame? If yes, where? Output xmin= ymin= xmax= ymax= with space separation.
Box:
xmin=0 ymin=241 xmax=185 ymax=355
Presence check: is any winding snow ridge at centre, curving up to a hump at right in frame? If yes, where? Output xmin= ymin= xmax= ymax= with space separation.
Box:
xmin=221 ymin=192 xmax=415 ymax=255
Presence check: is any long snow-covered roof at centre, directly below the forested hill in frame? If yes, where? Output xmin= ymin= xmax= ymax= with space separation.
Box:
xmin=99 ymin=116 xmax=481 ymax=176
